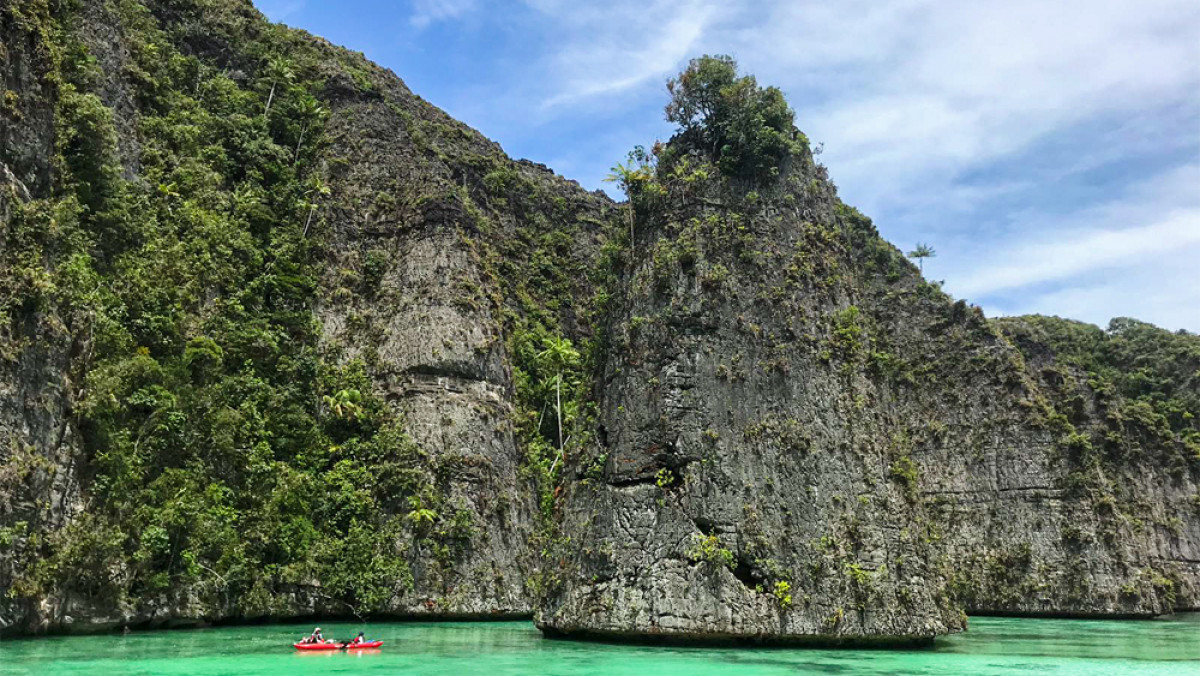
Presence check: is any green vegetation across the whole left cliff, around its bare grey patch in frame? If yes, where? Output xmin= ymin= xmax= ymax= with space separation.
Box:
xmin=0 ymin=0 xmax=607 ymax=626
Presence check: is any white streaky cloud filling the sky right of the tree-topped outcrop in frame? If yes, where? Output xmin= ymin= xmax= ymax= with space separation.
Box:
xmin=739 ymin=0 xmax=1200 ymax=330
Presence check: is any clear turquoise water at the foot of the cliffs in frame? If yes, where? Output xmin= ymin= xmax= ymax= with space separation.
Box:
xmin=0 ymin=614 xmax=1200 ymax=676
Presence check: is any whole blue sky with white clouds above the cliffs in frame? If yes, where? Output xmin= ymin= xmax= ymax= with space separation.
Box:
xmin=256 ymin=0 xmax=1200 ymax=333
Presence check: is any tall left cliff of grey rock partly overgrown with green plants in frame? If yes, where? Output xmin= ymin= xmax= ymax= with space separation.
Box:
xmin=0 ymin=0 xmax=612 ymax=632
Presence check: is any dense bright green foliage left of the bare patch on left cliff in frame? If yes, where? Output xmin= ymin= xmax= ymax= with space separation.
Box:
xmin=0 ymin=1 xmax=432 ymax=615
